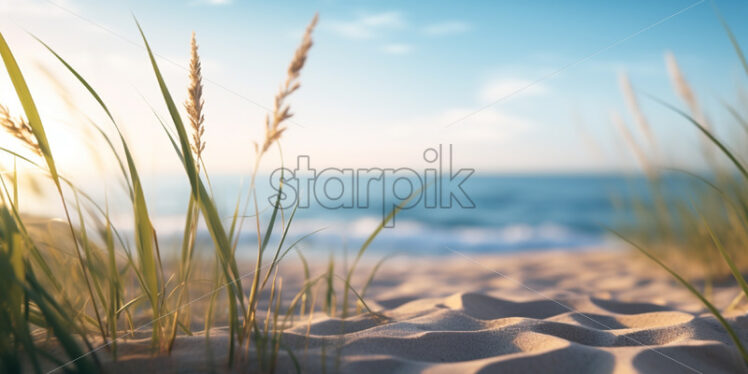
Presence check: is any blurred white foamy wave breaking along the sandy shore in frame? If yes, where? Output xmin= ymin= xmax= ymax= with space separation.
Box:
xmin=115 ymin=215 xmax=604 ymax=254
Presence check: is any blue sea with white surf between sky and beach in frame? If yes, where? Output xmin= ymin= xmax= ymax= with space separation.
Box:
xmin=95 ymin=174 xmax=693 ymax=255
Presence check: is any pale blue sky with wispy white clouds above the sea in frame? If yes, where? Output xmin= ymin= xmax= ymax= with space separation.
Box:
xmin=0 ymin=0 xmax=748 ymax=181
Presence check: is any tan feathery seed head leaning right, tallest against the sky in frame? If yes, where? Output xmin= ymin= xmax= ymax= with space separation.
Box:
xmin=259 ymin=14 xmax=318 ymax=155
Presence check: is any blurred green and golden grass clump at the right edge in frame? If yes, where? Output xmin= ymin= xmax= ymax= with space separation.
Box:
xmin=613 ymin=22 xmax=748 ymax=362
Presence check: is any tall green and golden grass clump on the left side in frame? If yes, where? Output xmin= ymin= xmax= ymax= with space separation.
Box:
xmin=0 ymin=11 xmax=414 ymax=373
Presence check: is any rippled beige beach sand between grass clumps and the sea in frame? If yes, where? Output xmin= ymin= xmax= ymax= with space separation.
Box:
xmin=93 ymin=251 xmax=748 ymax=374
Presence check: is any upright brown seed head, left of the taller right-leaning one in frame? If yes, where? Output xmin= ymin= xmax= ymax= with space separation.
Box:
xmin=184 ymin=32 xmax=205 ymax=170
